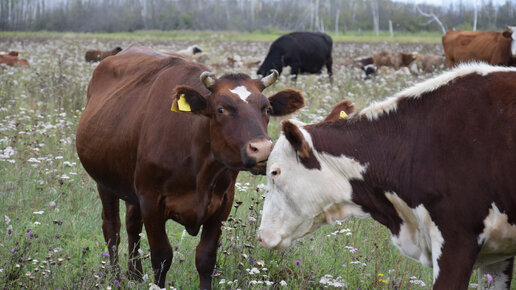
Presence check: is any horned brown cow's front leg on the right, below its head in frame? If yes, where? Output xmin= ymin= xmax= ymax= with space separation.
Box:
xmin=195 ymin=186 xmax=234 ymax=289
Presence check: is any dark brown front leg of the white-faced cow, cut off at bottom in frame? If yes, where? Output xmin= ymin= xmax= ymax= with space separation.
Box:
xmin=432 ymin=234 xmax=480 ymax=290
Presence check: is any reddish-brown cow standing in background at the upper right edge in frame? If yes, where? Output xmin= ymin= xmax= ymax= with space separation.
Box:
xmin=442 ymin=26 xmax=516 ymax=67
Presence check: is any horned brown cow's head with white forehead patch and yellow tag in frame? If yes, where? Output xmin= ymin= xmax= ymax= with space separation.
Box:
xmin=172 ymin=71 xmax=304 ymax=174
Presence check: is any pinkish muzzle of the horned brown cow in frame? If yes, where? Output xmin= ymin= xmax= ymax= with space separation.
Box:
xmin=243 ymin=137 xmax=273 ymax=175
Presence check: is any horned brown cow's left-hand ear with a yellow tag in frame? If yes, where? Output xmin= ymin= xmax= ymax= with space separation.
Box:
xmin=170 ymin=86 xmax=206 ymax=114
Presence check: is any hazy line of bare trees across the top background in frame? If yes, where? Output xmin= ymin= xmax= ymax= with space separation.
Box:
xmin=0 ymin=0 xmax=516 ymax=33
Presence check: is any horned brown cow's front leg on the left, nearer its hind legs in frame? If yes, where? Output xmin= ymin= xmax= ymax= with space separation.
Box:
xmin=140 ymin=195 xmax=172 ymax=288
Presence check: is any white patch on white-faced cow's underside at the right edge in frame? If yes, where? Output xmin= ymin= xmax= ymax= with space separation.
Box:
xmin=477 ymin=203 xmax=516 ymax=265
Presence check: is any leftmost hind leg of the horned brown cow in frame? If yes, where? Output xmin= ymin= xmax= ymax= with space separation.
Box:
xmin=97 ymin=185 xmax=120 ymax=275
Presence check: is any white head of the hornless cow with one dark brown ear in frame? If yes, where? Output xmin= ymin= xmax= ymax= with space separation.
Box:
xmin=258 ymin=121 xmax=366 ymax=249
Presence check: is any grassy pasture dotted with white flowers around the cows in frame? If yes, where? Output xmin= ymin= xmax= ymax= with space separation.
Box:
xmin=0 ymin=35 xmax=500 ymax=289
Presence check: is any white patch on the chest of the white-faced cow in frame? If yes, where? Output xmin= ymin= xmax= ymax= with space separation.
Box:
xmin=385 ymin=192 xmax=444 ymax=283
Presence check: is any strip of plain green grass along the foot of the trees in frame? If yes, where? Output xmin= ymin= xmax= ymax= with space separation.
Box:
xmin=0 ymin=30 xmax=442 ymax=43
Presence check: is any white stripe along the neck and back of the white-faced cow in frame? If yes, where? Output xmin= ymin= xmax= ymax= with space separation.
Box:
xmin=358 ymin=63 xmax=516 ymax=121
